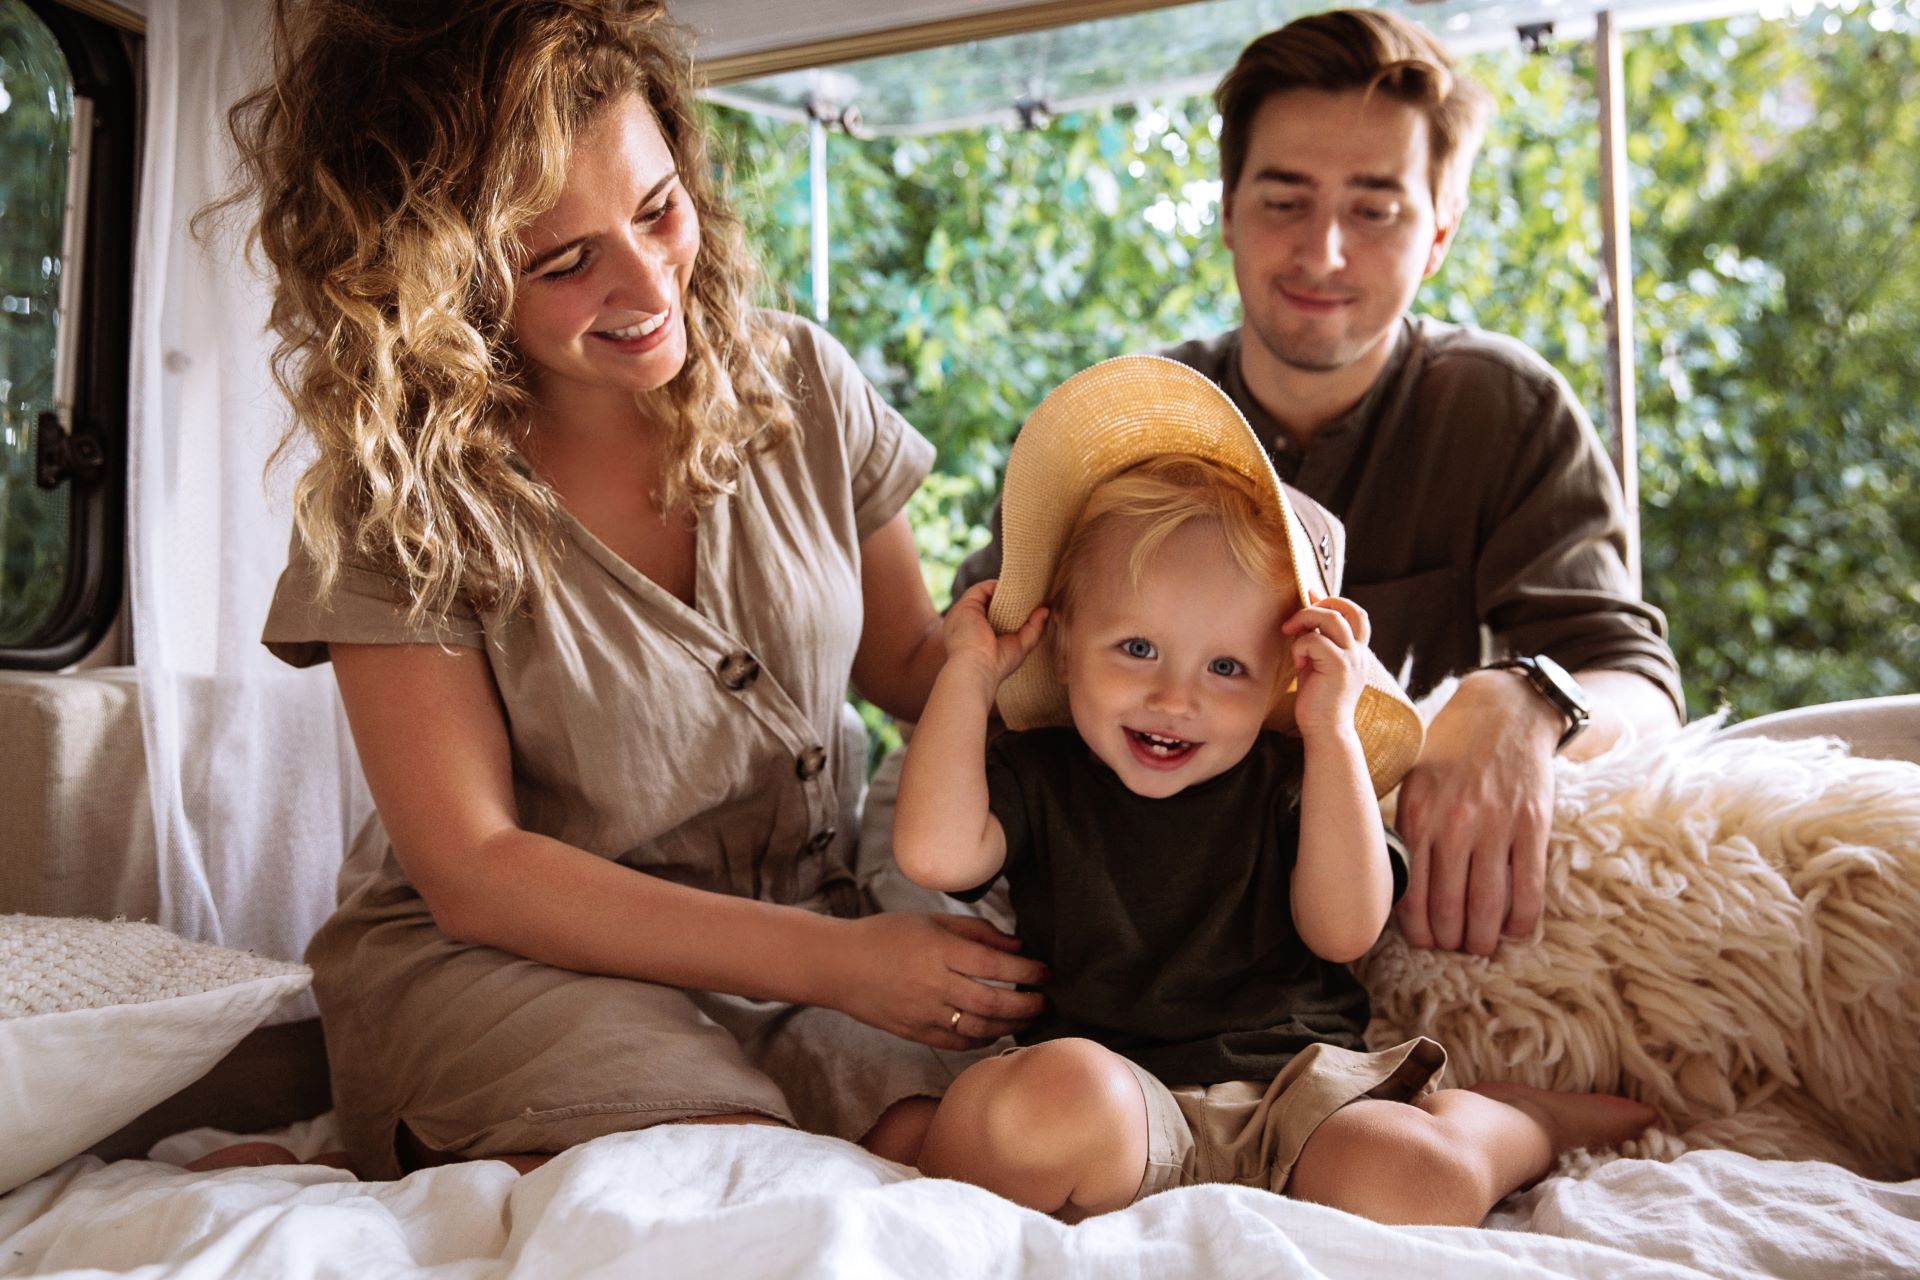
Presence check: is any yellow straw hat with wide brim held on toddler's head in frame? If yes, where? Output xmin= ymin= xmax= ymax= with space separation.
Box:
xmin=987 ymin=355 xmax=1423 ymax=794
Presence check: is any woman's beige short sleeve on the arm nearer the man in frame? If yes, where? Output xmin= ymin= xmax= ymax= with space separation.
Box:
xmin=789 ymin=317 xmax=933 ymax=541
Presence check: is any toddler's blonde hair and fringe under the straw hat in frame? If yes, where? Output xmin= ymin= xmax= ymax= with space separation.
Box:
xmin=1046 ymin=453 xmax=1296 ymax=620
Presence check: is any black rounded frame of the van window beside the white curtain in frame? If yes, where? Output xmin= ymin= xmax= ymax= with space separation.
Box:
xmin=0 ymin=0 xmax=140 ymax=670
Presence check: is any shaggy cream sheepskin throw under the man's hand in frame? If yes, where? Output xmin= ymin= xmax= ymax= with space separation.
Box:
xmin=1357 ymin=720 xmax=1920 ymax=1178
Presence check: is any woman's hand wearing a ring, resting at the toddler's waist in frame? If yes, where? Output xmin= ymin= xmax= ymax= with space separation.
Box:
xmin=818 ymin=912 xmax=1046 ymax=1050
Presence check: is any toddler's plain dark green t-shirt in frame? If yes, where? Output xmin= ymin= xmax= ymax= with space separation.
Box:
xmin=975 ymin=729 xmax=1405 ymax=1084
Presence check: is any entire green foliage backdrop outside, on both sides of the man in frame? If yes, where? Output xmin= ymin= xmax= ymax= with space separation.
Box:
xmin=718 ymin=0 xmax=1920 ymax=729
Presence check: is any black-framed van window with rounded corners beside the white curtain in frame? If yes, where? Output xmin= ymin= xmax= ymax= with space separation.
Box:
xmin=0 ymin=0 xmax=132 ymax=668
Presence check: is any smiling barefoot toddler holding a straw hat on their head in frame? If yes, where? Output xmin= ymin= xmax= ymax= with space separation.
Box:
xmin=895 ymin=357 xmax=1653 ymax=1224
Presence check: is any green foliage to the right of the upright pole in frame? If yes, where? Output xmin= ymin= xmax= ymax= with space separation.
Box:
xmin=1630 ymin=6 xmax=1920 ymax=712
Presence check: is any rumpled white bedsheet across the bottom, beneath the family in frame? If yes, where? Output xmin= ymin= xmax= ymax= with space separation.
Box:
xmin=0 ymin=1126 xmax=1920 ymax=1280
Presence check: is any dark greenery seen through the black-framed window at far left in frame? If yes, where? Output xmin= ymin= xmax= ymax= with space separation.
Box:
xmin=0 ymin=0 xmax=73 ymax=643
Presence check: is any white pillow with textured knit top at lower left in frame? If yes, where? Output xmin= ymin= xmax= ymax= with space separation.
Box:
xmin=0 ymin=915 xmax=313 ymax=1194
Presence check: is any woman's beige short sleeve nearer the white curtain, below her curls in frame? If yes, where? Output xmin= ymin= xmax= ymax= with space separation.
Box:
xmin=261 ymin=533 xmax=484 ymax=666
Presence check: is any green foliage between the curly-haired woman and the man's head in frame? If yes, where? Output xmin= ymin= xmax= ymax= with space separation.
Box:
xmin=718 ymin=100 xmax=1238 ymax=556
